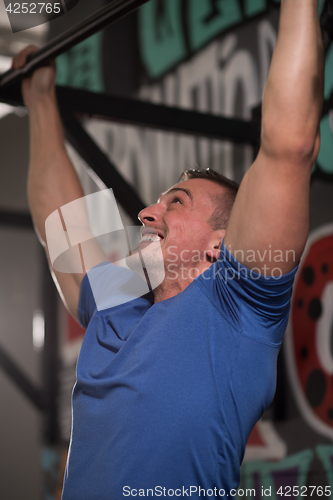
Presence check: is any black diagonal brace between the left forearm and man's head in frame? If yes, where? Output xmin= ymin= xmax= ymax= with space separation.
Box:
xmin=61 ymin=108 xmax=145 ymax=223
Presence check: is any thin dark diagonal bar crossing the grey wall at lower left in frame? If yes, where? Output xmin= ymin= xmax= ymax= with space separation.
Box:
xmin=0 ymin=347 xmax=45 ymax=410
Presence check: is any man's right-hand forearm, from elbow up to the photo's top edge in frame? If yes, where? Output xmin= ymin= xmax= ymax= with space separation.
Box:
xmin=262 ymin=0 xmax=324 ymax=156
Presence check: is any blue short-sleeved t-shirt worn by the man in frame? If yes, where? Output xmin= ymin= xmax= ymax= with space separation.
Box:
xmin=63 ymin=240 xmax=296 ymax=500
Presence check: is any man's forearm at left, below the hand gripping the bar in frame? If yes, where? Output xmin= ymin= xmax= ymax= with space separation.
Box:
xmin=28 ymin=92 xmax=83 ymax=243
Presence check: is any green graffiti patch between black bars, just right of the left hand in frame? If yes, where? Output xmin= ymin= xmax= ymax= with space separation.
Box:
xmin=57 ymin=33 xmax=104 ymax=92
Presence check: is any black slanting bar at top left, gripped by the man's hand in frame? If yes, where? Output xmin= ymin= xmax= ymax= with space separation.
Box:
xmin=0 ymin=0 xmax=149 ymax=88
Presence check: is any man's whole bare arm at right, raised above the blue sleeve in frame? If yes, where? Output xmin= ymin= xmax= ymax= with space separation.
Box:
xmin=225 ymin=0 xmax=324 ymax=275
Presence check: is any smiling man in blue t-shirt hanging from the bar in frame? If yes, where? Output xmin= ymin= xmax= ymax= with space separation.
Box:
xmin=14 ymin=0 xmax=324 ymax=500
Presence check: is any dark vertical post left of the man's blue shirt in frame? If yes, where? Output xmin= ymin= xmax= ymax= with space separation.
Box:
xmin=41 ymin=249 xmax=60 ymax=444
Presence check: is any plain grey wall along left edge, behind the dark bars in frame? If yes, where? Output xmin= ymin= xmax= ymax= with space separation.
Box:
xmin=0 ymin=114 xmax=42 ymax=500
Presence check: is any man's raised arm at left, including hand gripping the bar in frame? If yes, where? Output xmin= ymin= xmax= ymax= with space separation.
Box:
xmin=13 ymin=46 xmax=107 ymax=318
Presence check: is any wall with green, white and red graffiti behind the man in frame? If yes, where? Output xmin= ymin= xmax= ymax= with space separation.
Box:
xmin=55 ymin=0 xmax=333 ymax=499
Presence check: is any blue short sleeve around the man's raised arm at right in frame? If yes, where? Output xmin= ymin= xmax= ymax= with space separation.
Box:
xmin=198 ymin=241 xmax=298 ymax=343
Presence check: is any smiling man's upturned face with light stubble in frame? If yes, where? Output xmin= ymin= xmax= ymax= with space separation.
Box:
xmin=128 ymin=179 xmax=224 ymax=281
